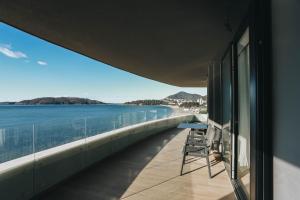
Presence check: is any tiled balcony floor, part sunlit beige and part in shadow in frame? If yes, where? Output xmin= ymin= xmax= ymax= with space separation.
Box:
xmin=40 ymin=129 xmax=235 ymax=200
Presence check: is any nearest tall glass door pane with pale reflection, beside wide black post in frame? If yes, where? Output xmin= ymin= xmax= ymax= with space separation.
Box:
xmin=237 ymin=29 xmax=250 ymax=198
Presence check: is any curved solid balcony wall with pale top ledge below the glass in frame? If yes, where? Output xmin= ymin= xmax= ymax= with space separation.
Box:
xmin=0 ymin=115 xmax=195 ymax=200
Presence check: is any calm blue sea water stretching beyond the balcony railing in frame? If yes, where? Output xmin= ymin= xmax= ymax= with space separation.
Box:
xmin=0 ymin=104 xmax=173 ymax=163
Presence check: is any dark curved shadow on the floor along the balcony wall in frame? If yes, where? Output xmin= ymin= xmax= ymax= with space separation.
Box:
xmin=37 ymin=129 xmax=182 ymax=200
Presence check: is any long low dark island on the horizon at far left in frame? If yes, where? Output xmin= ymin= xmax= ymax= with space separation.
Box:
xmin=1 ymin=97 xmax=103 ymax=105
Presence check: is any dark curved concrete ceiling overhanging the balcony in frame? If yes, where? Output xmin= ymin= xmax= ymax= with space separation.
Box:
xmin=0 ymin=0 xmax=248 ymax=87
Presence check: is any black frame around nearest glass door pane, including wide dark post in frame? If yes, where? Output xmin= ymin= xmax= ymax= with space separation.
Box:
xmin=224 ymin=0 xmax=273 ymax=200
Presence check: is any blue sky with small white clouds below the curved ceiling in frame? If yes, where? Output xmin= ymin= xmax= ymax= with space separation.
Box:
xmin=0 ymin=22 xmax=206 ymax=103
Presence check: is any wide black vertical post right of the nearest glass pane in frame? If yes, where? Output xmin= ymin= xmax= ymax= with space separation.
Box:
xmin=249 ymin=0 xmax=273 ymax=200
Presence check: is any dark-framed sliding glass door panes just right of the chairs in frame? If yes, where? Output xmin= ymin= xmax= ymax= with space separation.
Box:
xmin=218 ymin=24 xmax=255 ymax=199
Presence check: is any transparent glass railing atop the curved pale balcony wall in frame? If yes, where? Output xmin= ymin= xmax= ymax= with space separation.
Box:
xmin=0 ymin=106 xmax=178 ymax=163
